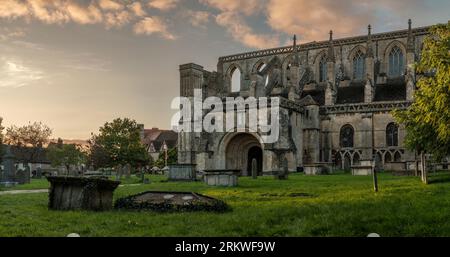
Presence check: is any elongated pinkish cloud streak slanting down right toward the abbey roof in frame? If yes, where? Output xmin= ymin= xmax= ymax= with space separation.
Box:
xmin=216 ymin=12 xmax=280 ymax=49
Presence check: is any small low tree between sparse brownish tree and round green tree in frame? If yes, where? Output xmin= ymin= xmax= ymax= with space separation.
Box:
xmin=47 ymin=144 xmax=86 ymax=173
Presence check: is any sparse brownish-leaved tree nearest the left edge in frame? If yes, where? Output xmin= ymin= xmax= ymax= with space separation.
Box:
xmin=5 ymin=122 xmax=52 ymax=163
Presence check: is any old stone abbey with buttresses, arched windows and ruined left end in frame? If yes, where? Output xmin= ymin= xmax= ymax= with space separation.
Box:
xmin=178 ymin=22 xmax=436 ymax=175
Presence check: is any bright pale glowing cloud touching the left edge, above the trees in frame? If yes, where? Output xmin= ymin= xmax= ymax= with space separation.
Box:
xmin=0 ymin=58 xmax=44 ymax=88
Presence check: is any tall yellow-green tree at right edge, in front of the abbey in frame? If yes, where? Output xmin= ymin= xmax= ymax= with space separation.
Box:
xmin=394 ymin=21 xmax=450 ymax=183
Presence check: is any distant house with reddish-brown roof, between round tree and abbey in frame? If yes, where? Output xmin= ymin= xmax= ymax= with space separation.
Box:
xmin=141 ymin=128 xmax=178 ymax=160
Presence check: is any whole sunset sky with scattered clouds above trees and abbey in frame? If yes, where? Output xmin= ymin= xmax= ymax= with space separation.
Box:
xmin=0 ymin=0 xmax=450 ymax=139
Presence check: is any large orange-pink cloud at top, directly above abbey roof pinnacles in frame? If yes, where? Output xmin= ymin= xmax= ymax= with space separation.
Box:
xmin=266 ymin=0 xmax=426 ymax=42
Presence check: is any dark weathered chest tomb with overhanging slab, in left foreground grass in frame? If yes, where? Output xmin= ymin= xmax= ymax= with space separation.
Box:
xmin=47 ymin=176 xmax=120 ymax=211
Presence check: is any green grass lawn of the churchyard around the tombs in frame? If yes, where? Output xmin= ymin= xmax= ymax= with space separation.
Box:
xmin=0 ymin=174 xmax=450 ymax=236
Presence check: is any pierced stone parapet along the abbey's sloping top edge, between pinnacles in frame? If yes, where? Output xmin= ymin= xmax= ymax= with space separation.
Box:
xmin=219 ymin=26 xmax=431 ymax=63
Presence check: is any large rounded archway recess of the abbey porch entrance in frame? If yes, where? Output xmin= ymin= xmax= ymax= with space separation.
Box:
xmin=225 ymin=133 xmax=263 ymax=176
